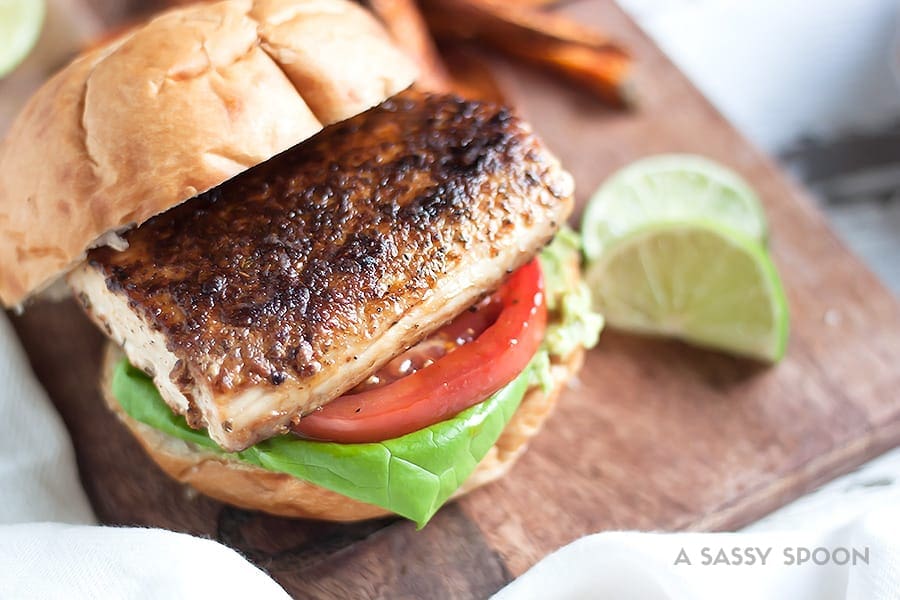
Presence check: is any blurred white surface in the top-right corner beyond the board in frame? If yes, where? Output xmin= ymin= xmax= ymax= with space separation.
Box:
xmin=619 ymin=0 xmax=900 ymax=153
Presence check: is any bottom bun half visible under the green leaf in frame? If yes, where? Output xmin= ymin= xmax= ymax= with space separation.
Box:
xmin=100 ymin=344 xmax=584 ymax=521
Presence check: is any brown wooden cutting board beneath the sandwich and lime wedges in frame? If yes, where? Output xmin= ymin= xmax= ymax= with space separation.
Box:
xmin=7 ymin=0 xmax=900 ymax=598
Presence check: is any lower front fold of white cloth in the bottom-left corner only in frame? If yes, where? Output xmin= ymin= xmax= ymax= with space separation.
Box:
xmin=0 ymin=523 xmax=288 ymax=600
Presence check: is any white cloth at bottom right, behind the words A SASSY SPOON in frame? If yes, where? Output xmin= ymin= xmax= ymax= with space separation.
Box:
xmin=495 ymin=507 xmax=900 ymax=600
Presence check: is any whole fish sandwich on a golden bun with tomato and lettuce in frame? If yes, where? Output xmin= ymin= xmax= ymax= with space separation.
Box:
xmin=0 ymin=0 xmax=602 ymax=526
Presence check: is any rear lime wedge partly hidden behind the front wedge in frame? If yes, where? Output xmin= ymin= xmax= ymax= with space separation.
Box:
xmin=581 ymin=154 xmax=766 ymax=260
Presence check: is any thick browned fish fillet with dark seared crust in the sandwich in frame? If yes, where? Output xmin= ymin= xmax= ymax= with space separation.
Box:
xmin=69 ymin=94 xmax=572 ymax=451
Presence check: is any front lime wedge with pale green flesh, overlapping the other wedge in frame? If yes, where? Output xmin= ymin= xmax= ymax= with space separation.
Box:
xmin=586 ymin=220 xmax=788 ymax=362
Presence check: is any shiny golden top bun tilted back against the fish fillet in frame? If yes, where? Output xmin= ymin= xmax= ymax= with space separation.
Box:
xmin=0 ymin=0 xmax=415 ymax=306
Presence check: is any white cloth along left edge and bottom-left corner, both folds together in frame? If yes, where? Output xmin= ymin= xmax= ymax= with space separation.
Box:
xmin=0 ymin=315 xmax=288 ymax=600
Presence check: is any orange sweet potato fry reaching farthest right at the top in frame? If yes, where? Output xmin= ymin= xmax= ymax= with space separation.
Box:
xmin=423 ymin=0 xmax=635 ymax=107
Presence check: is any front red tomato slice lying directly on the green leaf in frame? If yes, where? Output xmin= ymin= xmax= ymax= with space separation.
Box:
xmin=292 ymin=259 xmax=547 ymax=444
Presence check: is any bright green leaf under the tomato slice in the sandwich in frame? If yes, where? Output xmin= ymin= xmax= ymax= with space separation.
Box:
xmin=112 ymin=351 xmax=549 ymax=527
